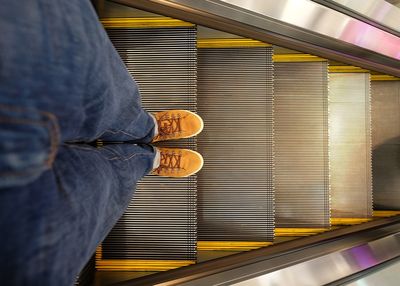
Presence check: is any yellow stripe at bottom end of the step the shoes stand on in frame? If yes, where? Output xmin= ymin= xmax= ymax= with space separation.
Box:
xmin=96 ymin=259 xmax=196 ymax=271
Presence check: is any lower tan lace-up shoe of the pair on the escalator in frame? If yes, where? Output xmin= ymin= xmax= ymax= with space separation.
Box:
xmin=152 ymin=148 xmax=204 ymax=178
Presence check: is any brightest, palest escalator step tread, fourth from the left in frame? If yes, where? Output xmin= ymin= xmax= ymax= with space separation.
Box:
xmin=329 ymin=73 xmax=372 ymax=218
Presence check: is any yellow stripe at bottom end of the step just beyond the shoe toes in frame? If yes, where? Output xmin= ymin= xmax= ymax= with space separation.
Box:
xmin=197 ymin=241 xmax=272 ymax=251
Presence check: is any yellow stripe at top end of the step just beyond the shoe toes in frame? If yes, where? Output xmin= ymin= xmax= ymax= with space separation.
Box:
xmin=197 ymin=38 xmax=271 ymax=49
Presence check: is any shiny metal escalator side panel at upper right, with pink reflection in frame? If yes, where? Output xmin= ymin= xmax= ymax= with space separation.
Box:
xmin=114 ymin=0 xmax=400 ymax=76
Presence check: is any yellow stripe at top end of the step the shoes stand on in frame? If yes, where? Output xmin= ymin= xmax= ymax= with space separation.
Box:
xmin=100 ymin=17 xmax=194 ymax=28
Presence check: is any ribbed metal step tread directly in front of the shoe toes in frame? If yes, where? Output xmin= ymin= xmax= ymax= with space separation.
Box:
xmin=198 ymin=47 xmax=274 ymax=241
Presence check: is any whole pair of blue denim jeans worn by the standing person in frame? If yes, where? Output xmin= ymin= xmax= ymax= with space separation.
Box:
xmin=0 ymin=0 xmax=155 ymax=286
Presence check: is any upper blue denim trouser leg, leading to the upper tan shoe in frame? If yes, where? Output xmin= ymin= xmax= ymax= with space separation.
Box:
xmin=0 ymin=0 xmax=154 ymax=143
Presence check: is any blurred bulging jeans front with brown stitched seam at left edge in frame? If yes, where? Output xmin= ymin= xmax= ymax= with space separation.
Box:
xmin=0 ymin=105 xmax=59 ymax=188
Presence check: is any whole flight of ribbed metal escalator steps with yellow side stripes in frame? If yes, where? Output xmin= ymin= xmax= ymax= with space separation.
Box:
xmin=77 ymin=1 xmax=400 ymax=285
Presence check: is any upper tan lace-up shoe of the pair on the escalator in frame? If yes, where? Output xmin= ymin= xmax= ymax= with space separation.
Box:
xmin=152 ymin=110 xmax=204 ymax=142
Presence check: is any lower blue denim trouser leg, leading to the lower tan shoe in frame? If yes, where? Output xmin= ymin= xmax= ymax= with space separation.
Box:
xmin=0 ymin=144 xmax=154 ymax=286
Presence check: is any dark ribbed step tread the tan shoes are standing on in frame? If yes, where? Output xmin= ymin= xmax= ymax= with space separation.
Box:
xmin=102 ymin=27 xmax=197 ymax=260
